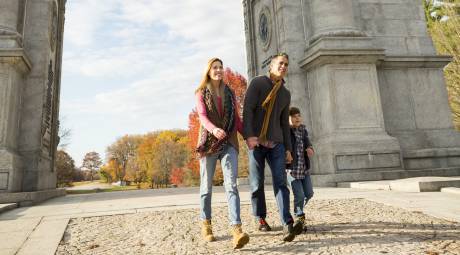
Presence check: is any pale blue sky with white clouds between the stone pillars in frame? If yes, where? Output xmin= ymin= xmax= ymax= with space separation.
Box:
xmin=60 ymin=0 xmax=247 ymax=167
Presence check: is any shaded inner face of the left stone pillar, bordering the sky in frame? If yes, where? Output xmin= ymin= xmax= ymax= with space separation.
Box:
xmin=18 ymin=0 xmax=65 ymax=191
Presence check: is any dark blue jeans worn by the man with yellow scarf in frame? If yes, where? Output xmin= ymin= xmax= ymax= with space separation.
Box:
xmin=249 ymin=144 xmax=292 ymax=225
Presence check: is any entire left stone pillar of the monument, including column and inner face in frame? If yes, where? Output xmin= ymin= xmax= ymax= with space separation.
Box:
xmin=0 ymin=0 xmax=65 ymax=205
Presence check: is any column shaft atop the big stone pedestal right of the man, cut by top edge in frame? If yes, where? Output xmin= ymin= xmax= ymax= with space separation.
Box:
xmin=310 ymin=0 xmax=364 ymax=42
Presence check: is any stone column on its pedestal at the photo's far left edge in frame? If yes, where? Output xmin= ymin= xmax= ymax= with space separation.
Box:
xmin=0 ymin=0 xmax=31 ymax=192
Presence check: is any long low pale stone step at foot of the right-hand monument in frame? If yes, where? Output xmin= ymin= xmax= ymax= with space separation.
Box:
xmin=338 ymin=176 xmax=460 ymax=192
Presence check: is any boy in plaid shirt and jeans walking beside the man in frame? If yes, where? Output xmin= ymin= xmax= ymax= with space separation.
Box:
xmin=286 ymin=107 xmax=314 ymax=234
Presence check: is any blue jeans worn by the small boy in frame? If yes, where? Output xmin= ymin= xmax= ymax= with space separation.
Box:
xmin=287 ymin=174 xmax=313 ymax=217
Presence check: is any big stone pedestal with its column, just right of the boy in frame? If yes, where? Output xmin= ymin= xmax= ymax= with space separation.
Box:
xmin=300 ymin=0 xmax=403 ymax=182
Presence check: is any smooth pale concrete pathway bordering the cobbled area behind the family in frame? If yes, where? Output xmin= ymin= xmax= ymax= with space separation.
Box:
xmin=0 ymin=186 xmax=460 ymax=255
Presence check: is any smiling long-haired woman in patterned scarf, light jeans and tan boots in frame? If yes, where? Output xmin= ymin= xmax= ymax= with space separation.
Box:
xmin=195 ymin=58 xmax=249 ymax=249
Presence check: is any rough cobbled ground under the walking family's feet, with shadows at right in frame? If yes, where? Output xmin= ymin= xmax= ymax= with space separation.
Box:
xmin=56 ymin=199 xmax=460 ymax=255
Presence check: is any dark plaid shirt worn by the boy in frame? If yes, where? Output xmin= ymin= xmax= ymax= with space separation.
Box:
xmin=288 ymin=125 xmax=310 ymax=179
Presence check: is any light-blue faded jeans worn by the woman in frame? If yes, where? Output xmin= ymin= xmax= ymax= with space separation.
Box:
xmin=200 ymin=145 xmax=241 ymax=225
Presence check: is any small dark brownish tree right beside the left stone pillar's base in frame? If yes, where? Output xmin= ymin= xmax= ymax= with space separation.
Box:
xmin=55 ymin=150 xmax=75 ymax=187
